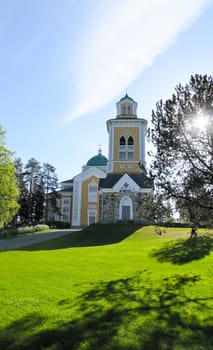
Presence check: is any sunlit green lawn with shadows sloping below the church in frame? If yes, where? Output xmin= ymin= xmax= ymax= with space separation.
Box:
xmin=0 ymin=225 xmax=213 ymax=350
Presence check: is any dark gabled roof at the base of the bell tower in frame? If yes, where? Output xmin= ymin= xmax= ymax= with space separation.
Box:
xmin=99 ymin=173 xmax=153 ymax=188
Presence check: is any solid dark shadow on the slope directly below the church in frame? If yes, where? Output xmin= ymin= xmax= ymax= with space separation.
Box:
xmin=18 ymin=224 xmax=141 ymax=251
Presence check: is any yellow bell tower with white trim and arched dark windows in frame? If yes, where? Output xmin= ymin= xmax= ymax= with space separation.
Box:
xmin=107 ymin=94 xmax=147 ymax=173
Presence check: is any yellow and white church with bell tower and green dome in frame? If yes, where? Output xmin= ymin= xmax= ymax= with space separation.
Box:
xmin=52 ymin=94 xmax=153 ymax=227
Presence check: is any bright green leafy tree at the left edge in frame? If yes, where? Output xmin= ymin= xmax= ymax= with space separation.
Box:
xmin=0 ymin=126 xmax=19 ymax=227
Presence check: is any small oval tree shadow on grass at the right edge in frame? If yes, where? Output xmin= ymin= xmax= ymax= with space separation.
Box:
xmin=151 ymin=235 xmax=213 ymax=265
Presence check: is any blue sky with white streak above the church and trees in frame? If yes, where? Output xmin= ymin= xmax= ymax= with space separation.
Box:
xmin=0 ymin=0 xmax=213 ymax=181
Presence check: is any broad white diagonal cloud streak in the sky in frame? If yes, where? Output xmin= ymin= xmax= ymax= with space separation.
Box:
xmin=66 ymin=0 xmax=209 ymax=120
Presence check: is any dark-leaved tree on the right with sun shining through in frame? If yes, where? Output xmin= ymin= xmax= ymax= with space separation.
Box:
xmin=150 ymin=75 xmax=213 ymax=225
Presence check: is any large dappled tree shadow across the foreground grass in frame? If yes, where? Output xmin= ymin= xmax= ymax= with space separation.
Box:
xmin=0 ymin=271 xmax=213 ymax=350
